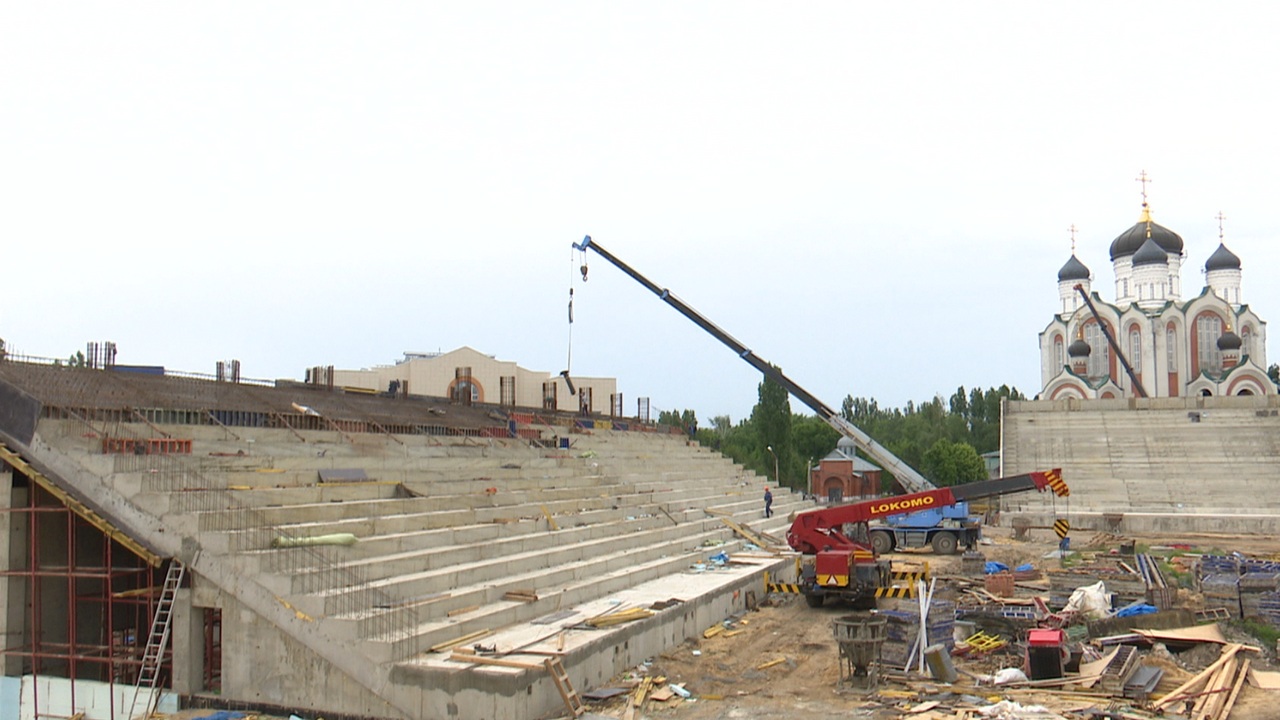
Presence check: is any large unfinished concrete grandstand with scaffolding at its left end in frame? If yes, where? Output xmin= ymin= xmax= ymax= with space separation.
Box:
xmin=0 ymin=361 xmax=808 ymax=720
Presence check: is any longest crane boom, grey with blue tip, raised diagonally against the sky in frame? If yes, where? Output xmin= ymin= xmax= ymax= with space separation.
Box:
xmin=573 ymin=236 xmax=937 ymax=492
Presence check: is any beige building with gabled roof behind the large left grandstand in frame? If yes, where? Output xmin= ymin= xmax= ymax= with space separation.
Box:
xmin=327 ymin=346 xmax=622 ymax=415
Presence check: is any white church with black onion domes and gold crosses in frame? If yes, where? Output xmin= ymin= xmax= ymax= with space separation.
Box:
xmin=1039 ymin=192 xmax=1276 ymax=400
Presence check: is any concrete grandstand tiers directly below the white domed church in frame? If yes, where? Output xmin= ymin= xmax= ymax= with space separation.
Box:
xmin=1001 ymin=395 xmax=1280 ymax=536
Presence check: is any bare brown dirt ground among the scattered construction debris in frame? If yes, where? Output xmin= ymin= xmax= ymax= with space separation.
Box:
xmin=588 ymin=528 xmax=1280 ymax=720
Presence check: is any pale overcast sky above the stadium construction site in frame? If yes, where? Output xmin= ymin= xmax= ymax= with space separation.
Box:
xmin=0 ymin=1 xmax=1280 ymax=421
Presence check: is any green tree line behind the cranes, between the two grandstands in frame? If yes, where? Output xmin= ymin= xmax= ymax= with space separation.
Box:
xmin=658 ymin=378 xmax=1027 ymax=492
